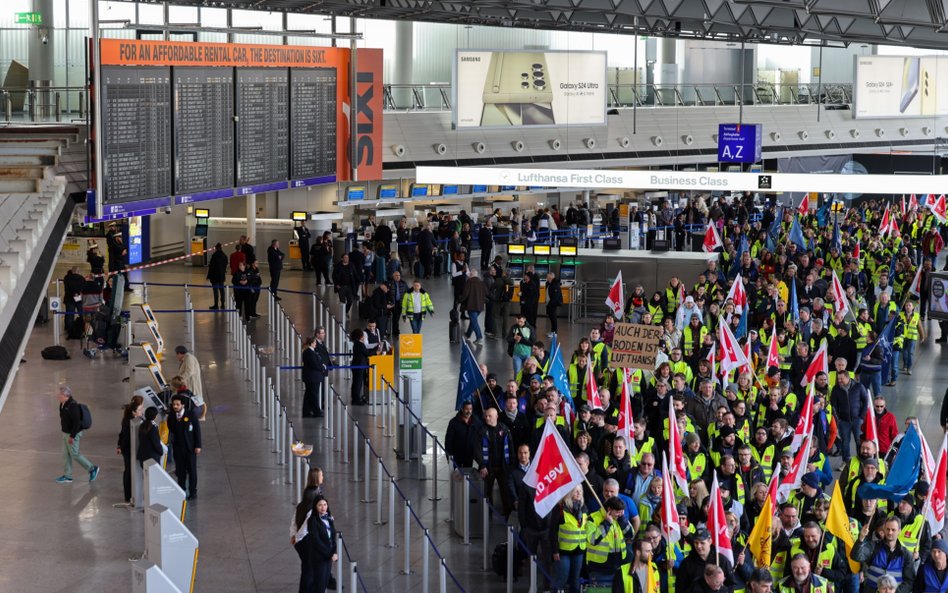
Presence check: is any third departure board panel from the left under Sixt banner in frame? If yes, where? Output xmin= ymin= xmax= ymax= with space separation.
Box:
xmin=236 ymin=68 xmax=290 ymax=188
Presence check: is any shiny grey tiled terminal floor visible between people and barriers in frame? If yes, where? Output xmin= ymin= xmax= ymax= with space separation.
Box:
xmin=0 ymin=256 xmax=948 ymax=593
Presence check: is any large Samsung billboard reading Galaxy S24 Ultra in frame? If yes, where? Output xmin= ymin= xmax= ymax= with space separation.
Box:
xmin=453 ymin=50 xmax=608 ymax=128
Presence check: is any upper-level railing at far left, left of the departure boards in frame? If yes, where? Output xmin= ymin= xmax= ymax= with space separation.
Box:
xmin=0 ymin=86 xmax=89 ymax=123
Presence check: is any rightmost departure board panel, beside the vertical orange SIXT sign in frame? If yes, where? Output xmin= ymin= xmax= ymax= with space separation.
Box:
xmin=290 ymin=68 xmax=336 ymax=179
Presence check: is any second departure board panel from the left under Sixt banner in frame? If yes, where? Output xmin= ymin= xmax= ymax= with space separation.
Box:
xmin=173 ymin=67 xmax=234 ymax=195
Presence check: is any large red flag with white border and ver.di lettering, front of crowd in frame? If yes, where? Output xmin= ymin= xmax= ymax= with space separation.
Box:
xmin=523 ymin=418 xmax=585 ymax=517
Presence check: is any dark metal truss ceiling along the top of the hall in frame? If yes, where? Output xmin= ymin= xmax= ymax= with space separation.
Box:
xmin=174 ymin=0 xmax=948 ymax=49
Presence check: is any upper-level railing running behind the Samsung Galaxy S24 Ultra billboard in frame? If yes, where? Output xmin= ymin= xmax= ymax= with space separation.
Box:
xmin=382 ymin=82 xmax=853 ymax=111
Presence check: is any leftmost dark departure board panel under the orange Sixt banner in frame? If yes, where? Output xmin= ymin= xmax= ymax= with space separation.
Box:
xmin=101 ymin=66 xmax=172 ymax=202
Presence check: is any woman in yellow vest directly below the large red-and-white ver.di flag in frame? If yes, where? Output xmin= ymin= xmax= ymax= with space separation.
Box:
xmin=550 ymin=484 xmax=592 ymax=593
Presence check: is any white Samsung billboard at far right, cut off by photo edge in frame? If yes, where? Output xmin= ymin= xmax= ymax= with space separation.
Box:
xmin=853 ymin=56 xmax=948 ymax=118
